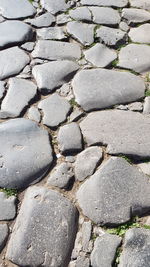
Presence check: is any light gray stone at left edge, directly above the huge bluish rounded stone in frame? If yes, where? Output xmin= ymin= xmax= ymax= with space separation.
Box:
xmin=0 ymin=78 xmax=37 ymax=118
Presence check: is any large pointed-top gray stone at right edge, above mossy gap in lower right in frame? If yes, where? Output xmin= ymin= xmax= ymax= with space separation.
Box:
xmin=76 ymin=157 xmax=150 ymax=226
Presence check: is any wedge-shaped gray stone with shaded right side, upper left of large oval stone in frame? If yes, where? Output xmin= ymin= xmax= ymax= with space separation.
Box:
xmin=32 ymin=60 xmax=79 ymax=93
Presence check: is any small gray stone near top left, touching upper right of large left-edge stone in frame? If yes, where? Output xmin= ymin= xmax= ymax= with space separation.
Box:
xmin=26 ymin=12 xmax=55 ymax=28
